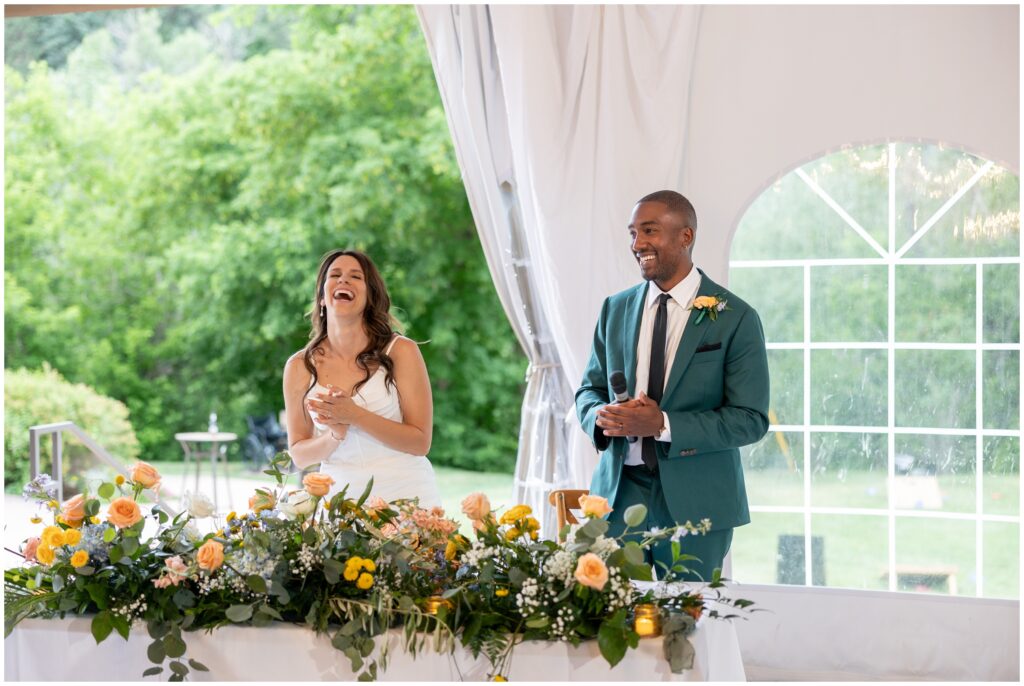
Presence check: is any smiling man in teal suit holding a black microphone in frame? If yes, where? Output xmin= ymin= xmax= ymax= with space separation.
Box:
xmin=575 ymin=190 xmax=768 ymax=581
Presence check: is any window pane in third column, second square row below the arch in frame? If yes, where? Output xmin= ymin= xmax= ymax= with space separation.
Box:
xmin=897 ymin=350 xmax=977 ymax=429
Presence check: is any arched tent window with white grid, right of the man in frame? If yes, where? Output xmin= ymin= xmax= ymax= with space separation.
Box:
xmin=730 ymin=142 xmax=1021 ymax=598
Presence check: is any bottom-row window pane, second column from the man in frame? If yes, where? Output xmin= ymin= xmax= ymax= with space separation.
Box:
xmin=811 ymin=515 xmax=889 ymax=591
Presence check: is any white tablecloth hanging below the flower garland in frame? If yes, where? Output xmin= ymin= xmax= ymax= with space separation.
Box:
xmin=4 ymin=617 xmax=745 ymax=682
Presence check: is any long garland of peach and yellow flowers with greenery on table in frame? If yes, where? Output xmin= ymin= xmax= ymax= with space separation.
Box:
xmin=4 ymin=453 xmax=751 ymax=681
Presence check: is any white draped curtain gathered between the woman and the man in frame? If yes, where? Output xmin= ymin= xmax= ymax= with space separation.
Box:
xmin=418 ymin=5 xmax=700 ymax=535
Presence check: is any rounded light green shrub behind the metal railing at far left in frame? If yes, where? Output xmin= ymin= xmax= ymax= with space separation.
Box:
xmin=3 ymin=363 xmax=139 ymax=495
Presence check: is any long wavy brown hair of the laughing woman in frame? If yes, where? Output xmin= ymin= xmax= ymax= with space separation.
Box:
xmin=302 ymin=250 xmax=401 ymax=395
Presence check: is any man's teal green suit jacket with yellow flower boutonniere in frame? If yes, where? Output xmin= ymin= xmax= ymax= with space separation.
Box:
xmin=575 ymin=271 xmax=769 ymax=529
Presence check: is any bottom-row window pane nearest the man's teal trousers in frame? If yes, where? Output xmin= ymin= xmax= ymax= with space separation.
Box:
xmin=731 ymin=512 xmax=804 ymax=584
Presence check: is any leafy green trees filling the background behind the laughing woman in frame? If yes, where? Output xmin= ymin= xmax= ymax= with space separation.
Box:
xmin=4 ymin=6 xmax=526 ymax=472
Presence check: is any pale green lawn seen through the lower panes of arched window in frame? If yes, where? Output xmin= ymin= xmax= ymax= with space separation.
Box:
xmin=732 ymin=470 xmax=1020 ymax=598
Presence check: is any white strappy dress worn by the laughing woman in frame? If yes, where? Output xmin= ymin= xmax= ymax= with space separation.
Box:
xmin=309 ymin=343 xmax=441 ymax=508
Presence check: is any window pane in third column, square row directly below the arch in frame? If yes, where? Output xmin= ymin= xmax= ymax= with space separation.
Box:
xmin=896 ymin=264 xmax=976 ymax=343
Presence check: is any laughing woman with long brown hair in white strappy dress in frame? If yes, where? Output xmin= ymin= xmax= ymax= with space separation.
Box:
xmin=284 ymin=250 xmax=440 ymax=508
